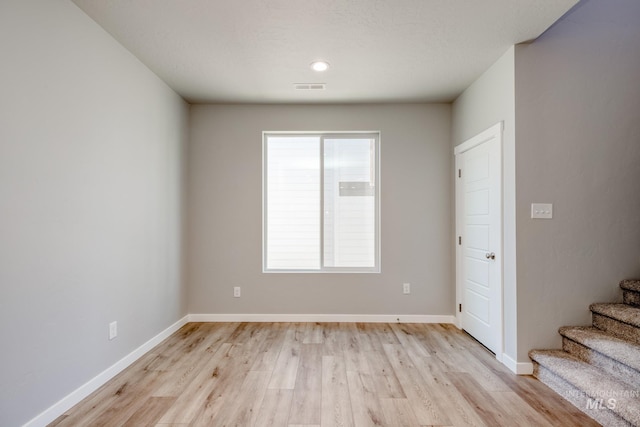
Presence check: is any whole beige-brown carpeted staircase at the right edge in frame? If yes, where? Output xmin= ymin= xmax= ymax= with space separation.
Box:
xmin=529 ymin=280 xmax=640 ymax=427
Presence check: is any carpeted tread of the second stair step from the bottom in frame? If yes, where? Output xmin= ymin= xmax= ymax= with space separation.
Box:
xmin=559 ymin=326 xmax=640 ymax=372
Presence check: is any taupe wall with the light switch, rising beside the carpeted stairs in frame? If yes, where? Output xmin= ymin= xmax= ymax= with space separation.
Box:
xmin=516 ymin=0 xmax=640 ymax=360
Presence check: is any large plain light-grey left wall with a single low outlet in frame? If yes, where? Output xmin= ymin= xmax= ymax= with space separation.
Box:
xmin=0 ymin=0 xmax=188 ymax=426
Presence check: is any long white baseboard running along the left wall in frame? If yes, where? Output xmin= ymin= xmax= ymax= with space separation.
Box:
xmin=23 ymin=315 xmax=189 ymax=427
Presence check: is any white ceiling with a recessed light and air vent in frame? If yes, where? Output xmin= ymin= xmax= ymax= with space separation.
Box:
xmin=73 ymin=0 xmax=578 ymax=103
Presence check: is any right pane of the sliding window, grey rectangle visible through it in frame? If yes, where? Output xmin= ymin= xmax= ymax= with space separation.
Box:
xmin=324 ymin=138 xmax=376 ymax=267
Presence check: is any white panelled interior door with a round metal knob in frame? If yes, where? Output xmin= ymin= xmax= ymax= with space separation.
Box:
xmin=456 ymin=123 xmax=503 ymax=358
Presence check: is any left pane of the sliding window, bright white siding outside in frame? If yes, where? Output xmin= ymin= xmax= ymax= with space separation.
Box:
xmin=266 ymin=136 xmax=320 ymax=270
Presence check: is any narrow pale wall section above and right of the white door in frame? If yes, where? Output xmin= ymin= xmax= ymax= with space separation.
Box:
xmin=451 ymin=47 xmax=517 ymax=369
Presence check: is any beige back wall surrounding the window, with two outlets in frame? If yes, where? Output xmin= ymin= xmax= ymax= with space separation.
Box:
xmin=188 ymin=105 xmax=454 ymax=315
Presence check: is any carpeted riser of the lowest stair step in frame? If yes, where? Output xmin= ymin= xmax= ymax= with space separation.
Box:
xmin=533 ymin=361 xmax=632 ymax=427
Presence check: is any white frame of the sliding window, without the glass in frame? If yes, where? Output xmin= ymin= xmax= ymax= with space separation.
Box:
xmin=262 ymin=131 xmax=382 ymax=273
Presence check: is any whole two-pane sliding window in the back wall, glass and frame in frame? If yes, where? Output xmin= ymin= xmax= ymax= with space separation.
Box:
xmin=263 ymin=132 xmax=380 ymax=272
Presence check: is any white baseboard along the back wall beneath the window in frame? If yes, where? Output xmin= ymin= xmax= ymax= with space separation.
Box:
xmin=189 ymin=314 xmax=456 ymax=324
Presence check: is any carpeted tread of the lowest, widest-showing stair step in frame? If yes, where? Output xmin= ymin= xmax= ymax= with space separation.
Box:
xmin=529 ymin=350 xmax=640 ymax=425
